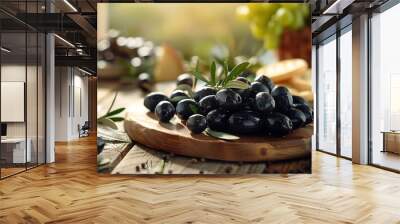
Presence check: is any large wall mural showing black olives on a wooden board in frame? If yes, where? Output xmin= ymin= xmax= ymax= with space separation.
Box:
xmin=97 ymin=3 xmax=313 ymax=174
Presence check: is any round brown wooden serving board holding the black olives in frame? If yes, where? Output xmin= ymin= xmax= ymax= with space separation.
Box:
xmin=124 ymin=106 xmax=313 ymax=162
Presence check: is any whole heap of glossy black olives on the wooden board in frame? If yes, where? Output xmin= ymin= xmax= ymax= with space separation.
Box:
xmin=144 ymin=74 xmax=313 ymax=137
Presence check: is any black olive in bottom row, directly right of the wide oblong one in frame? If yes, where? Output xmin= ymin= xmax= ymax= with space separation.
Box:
xmin=265 ymin=113 xmax=293 ymax=137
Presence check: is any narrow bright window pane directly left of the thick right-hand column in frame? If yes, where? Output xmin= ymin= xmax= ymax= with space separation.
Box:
xmin=340 ymin=30 xmax=352 ymax=158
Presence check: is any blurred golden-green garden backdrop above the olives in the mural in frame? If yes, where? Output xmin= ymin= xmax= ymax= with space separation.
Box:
xmin=98 ymin=3 xmax=312 ymax=101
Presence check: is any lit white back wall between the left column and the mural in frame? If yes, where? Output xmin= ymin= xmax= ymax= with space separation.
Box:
xmin=55 ymin=67 xmax=88 ymax=141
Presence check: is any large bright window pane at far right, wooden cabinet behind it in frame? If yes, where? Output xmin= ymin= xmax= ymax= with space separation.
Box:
xmin=371 ymin=4 xmax=400 ymax=170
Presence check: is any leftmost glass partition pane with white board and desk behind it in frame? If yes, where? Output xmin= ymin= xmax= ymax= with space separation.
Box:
xmin=0 ymin=32 xmax=27 ymax=177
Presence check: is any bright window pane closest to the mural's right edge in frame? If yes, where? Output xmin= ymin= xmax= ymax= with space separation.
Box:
xmin=317 ymin=38 xmax=337 ymax=153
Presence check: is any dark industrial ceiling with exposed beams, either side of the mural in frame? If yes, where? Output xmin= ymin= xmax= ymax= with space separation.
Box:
xmin=0 ymin=0 xmax=387 ymax=71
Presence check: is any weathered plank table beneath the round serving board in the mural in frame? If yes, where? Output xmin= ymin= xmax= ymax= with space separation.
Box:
xmin=97 ymin=82 xmax=311 ymax=175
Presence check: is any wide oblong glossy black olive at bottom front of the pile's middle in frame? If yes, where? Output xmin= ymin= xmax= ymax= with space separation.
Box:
xmin=228 ymin=111 xmax=262 ymax=135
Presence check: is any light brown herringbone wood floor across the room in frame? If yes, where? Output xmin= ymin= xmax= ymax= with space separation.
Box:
xmin=0 ymin=137 xmax=400 ymax=224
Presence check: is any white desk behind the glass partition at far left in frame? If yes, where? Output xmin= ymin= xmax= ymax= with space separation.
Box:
xmin=1 ymin=138 xmax=32 ymax=163
